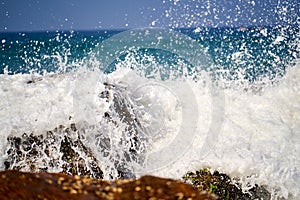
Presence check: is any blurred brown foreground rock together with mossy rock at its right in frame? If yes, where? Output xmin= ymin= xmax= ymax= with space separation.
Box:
xmin=0 ymin=169 xmax=271 ymax=200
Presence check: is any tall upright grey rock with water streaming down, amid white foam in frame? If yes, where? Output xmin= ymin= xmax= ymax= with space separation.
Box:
xmin=95 ymin=83 xmax=146 ymax=179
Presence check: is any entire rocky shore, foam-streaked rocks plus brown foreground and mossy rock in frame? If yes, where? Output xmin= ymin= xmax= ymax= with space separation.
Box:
xmin=0 ymin=80 xmax=271 ymax=200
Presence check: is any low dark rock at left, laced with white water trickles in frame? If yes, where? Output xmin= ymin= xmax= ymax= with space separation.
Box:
xmin=4 ymin=124 xmax=103 ymax=178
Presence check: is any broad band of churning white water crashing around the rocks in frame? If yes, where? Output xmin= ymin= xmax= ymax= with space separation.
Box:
xmin=0 ymin=60 xmax=300 ymax=199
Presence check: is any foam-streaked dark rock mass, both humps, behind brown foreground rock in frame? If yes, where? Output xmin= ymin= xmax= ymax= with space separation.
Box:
xmin=1 ymin=80 xmax=145 ymax=179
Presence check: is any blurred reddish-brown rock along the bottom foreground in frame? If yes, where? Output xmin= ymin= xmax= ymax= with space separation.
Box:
xmin=0 ymin=170 xmax=217 ymax=200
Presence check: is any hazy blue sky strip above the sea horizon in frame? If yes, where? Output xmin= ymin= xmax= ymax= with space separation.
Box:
xmin=0 ymin=0 xmax=300 ymax=32
